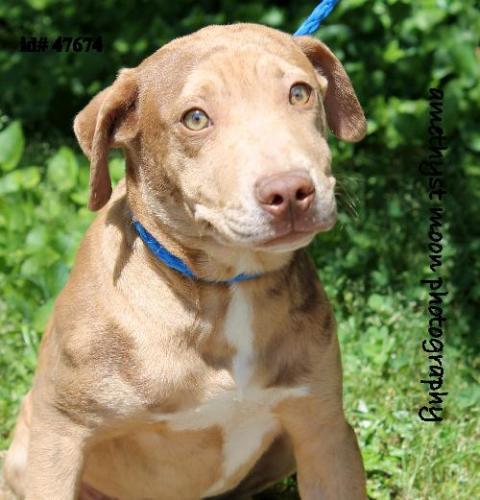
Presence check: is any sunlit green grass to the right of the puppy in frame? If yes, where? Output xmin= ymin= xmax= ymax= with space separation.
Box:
xmin=340 ymin=293 xmax=480 ymax=499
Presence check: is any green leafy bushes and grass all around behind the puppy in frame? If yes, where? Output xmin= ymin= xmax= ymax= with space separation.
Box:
xmin=0 ymin=0 xmax=480 ymax=500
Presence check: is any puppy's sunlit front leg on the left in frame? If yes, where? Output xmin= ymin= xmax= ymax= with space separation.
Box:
xmin=25 ymin=405 xmax=90 ymax=500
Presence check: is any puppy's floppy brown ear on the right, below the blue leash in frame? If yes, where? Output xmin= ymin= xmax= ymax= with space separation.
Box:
xmin=293 ymin=36 xmax=367 ymax=142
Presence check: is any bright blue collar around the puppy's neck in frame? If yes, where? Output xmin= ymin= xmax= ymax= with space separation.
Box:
xmin=133 ymin=219 xmax=260 ymax=285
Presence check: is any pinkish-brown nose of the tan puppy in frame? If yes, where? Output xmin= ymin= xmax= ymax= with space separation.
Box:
xmin=255 ymin=170 xmax=315 ymax=218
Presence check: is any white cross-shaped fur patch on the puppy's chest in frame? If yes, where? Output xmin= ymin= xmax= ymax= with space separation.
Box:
xmin=157 ymin=288 xmax=308 ymax=496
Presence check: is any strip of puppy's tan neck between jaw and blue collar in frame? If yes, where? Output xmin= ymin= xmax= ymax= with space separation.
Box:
xmin=127 ymin=182 xmax=293 ymax=281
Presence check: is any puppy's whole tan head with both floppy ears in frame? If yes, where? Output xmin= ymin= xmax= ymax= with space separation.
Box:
xmin=75 ymin=25 xmax=365 ymax=251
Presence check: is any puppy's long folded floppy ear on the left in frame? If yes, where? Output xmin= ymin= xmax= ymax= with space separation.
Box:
xmin=73 ymin=69 xmax=138 ymax=210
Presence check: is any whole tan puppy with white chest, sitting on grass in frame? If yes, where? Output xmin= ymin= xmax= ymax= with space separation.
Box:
xmin=5 ymin=24 xmax=365 ymax=500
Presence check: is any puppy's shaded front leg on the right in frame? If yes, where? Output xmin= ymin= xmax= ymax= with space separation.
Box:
xmin=279 ymin=396 xmax=367 ymax=500
